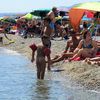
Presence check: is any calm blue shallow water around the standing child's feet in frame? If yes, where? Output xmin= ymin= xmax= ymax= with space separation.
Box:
xmin=0 ymin=48 xmax=100 ymax=100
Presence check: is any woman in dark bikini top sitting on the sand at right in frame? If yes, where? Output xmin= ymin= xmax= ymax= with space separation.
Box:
xmin=69 ymin=30 xmax=97 ymax=61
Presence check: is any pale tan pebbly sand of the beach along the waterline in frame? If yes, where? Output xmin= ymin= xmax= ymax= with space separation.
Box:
xmin=1 ymin=35 xmax=100 ymax=90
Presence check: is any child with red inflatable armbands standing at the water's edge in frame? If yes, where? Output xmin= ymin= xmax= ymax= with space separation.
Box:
xmin=30 ymin=36 xmax=51 ymax=79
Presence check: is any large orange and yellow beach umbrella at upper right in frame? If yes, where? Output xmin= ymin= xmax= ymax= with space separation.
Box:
xmin=69 ymin=2 xmax=100 ymax=31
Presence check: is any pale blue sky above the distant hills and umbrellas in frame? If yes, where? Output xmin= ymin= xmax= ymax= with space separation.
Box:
xmin=0 ymin=0 xmax=100 ymax=13
